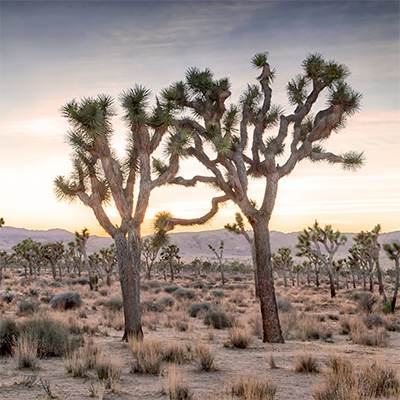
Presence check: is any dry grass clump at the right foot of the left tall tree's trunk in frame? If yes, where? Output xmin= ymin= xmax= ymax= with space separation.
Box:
xmin=128 ymin=339 xmax=163 ymax=375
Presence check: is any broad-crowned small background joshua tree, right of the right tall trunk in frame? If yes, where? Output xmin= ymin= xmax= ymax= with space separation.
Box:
xmin=297 ymin=221 xmax=347 ymax=297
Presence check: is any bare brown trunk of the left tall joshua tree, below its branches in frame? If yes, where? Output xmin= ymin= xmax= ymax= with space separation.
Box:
xmin=114 ymin=231 xmax=143 ymax=340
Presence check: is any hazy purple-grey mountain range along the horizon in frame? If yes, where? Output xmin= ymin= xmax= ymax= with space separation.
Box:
xmin=0 ymin=226 xmax=400 ymax=260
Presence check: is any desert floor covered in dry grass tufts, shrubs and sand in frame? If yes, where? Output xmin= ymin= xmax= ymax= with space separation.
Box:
xmin=0 ymin=272 xmax=400 ymax=400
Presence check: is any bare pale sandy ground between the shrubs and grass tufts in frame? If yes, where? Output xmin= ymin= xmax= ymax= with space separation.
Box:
xmin=0 ymin=276 xmax=400 ymax=400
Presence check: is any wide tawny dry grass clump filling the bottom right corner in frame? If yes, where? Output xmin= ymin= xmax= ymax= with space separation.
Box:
xmin=313 ymin=357 xmax=400 ymax=400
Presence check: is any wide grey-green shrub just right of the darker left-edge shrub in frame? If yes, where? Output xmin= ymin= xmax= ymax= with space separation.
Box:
xmin=20 ymin=316 xmax=79 ymax=358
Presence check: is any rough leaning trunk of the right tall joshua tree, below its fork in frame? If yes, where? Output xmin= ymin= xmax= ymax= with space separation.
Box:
xmin=252 ymin=219 xmax=284 ymax=343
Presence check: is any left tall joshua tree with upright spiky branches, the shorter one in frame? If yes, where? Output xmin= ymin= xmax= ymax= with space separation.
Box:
xmin=55 ymin=86 xmax=183 ymax=340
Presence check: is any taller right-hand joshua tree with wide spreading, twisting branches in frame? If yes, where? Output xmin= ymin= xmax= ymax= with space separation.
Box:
xmin=154 ymin=53 xmax=363 ymax=342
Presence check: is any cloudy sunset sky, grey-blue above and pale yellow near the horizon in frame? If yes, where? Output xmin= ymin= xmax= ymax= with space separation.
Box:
xmin=0 ymin=0 xmax=400 ymax=234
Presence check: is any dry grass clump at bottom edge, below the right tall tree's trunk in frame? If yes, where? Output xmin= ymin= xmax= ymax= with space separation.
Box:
xmin=231 ymin=376 xmax=276 ymax=400
